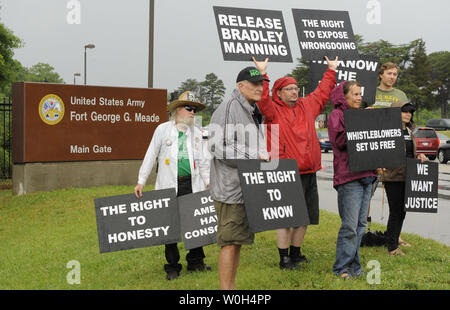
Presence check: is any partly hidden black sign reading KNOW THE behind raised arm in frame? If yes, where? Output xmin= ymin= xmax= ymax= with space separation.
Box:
xmin=308 ymin=55 xmax=380 ymax=105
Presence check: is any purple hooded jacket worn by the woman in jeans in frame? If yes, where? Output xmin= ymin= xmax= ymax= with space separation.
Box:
xmin=328 ymin=82 xmax=377 ymax=188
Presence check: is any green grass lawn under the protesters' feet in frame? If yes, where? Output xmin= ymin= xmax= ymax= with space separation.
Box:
xmin=0 ymin=186 xmax=450 ymax=290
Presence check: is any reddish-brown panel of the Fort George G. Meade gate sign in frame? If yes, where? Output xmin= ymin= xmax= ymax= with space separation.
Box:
xmin=13 ymin=82 xmax=167 ymax=163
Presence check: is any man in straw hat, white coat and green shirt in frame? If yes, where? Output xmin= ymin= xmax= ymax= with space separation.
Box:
xmin=134 ymin=91 xmax=211 ymax=280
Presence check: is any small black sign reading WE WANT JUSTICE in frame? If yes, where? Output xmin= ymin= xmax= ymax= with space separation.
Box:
xmin=405 ymin=158 xmax=439 ymax=213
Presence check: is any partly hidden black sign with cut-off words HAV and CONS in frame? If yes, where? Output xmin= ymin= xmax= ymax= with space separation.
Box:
xmin=178 ymin=190 xmax=217 ymax=250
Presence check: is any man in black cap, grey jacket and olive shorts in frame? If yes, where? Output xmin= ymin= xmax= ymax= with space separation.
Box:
xmin=208 ymin=67 xmax=268 ymax=289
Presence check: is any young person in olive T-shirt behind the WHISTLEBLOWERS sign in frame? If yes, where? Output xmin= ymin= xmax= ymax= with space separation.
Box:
xmin=373 ymin=62 xmax=408 ymax=108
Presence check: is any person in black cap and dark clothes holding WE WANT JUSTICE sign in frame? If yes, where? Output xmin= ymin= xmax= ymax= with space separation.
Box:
xmin=381 ymin=102 xmax=427 ymax=256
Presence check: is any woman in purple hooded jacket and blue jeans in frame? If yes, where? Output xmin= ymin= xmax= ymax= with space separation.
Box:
xmin=328 ymin=81 xmax=376 ymax=279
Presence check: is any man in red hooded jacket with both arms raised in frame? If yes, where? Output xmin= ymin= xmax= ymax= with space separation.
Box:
xmin=253 ymin=57 xmax=338 ymax=269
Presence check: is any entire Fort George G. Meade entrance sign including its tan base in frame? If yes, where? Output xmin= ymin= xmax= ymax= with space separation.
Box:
xmin=13 ymin=82 xmax=167 ymax=194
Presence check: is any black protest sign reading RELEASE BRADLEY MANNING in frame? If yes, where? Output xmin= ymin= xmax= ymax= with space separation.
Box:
xmin=213 ymin=6 xmax=292 ymax=62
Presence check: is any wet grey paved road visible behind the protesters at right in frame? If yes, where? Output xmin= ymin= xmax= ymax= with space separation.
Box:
xmin=317 ymin=153 xmax=450 ymax=245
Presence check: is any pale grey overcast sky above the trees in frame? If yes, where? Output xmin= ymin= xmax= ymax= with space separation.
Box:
xmin=0 ymin=0 xmax=450 ymax=95
